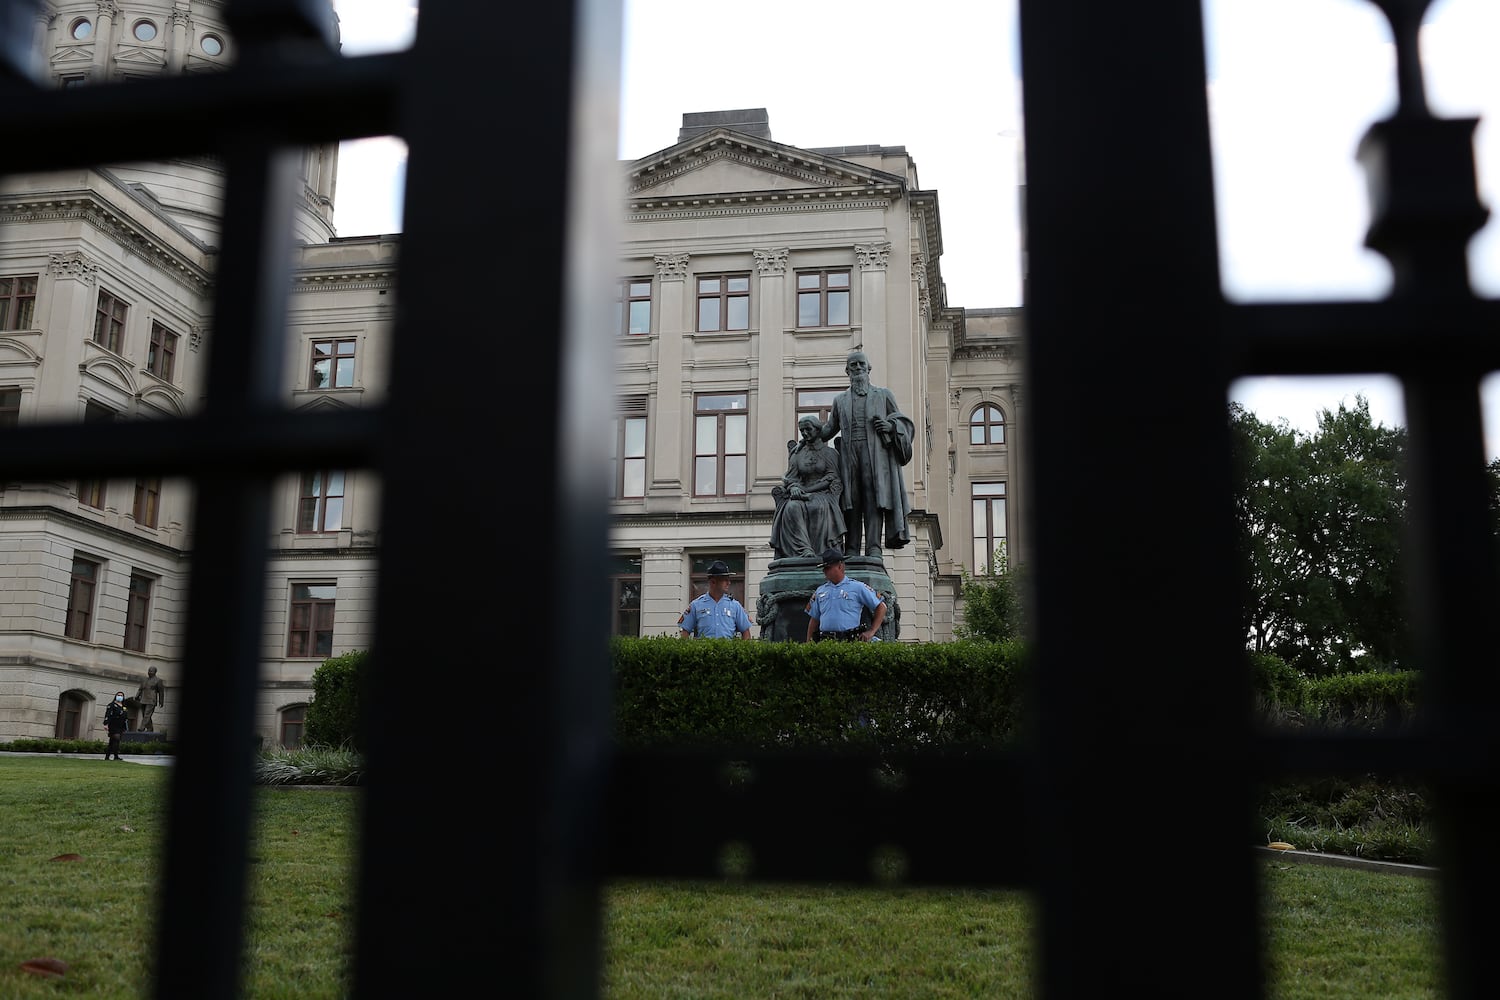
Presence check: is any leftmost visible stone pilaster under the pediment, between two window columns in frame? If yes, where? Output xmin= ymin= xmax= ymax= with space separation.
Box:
xmin=642 ymin=253 xmax=693 ymax=503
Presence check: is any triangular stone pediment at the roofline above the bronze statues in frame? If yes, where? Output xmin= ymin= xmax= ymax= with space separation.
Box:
xmin=629 ymin=129 xmax=905 ymax=204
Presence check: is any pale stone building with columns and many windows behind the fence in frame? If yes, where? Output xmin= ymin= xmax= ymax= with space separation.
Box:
xmin=0 ymin=7 xmax=1025 ymax=745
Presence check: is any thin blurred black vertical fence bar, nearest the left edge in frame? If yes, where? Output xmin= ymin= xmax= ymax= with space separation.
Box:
xmin=153 ymin=130 xmax=299 ymax=1000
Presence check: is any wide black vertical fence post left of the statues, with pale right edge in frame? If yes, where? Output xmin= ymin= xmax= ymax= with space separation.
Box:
xmin=356 ymin=0 xmax=620 ymax=997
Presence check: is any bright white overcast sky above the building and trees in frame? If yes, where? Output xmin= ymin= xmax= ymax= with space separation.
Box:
xmin=335 ymin=0 xmax=1500 ymax=456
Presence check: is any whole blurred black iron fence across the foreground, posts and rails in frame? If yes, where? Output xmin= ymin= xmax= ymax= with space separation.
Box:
xmin=0 ymin=0 xmax=1500 ymax=1000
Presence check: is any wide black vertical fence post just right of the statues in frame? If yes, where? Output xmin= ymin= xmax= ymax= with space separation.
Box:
xmin=1020 ymin=0 xmax=1262 ymax=997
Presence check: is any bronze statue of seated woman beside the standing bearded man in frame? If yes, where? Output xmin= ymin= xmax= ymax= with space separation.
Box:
xmin=771 ymin=415 xmax=845 ymax=559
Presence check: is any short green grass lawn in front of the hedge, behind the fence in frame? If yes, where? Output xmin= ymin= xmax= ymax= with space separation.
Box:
xmin=0 ymin=754 xmax=1443 ymax=1000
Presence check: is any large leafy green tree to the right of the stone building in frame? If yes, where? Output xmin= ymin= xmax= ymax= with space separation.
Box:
xmin=1230 ymin=396 xmax=1410 ymax=676
